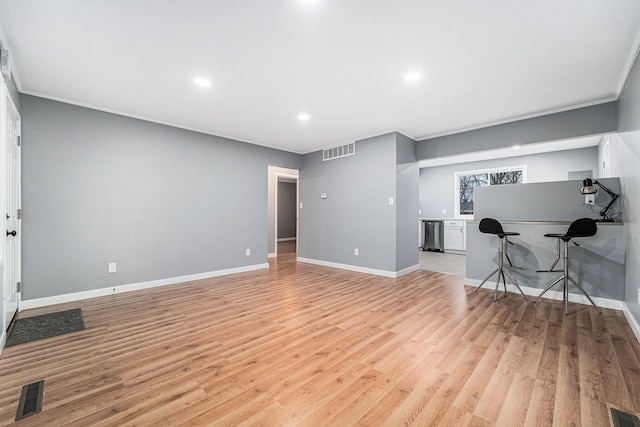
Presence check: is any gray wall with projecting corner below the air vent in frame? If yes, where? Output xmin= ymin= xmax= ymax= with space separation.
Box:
xmin=298 ymin=133 xmax=418 ymax=272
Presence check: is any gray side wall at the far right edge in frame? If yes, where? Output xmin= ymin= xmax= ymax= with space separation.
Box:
xmin=612 ymin=50 xmax=640 ymax=323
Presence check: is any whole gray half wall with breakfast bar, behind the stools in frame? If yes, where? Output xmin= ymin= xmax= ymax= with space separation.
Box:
xmin=465 ymin=178 xmax=626 ymax=308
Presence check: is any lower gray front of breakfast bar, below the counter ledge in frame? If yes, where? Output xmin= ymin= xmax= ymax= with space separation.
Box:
xmin=466 ymin=221 xmax=625 ymax=304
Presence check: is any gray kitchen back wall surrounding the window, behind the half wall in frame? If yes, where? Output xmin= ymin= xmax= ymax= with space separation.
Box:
xmin=420 ymin=147 xmax=598 ymax=218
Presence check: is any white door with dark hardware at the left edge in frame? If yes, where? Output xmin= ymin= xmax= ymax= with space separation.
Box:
xmin=2 ymin=91 xmax=21 ymax=327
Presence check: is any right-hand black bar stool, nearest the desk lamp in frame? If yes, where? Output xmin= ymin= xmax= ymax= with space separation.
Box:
xmin=533 ymin=218 xmax=602 ymax=315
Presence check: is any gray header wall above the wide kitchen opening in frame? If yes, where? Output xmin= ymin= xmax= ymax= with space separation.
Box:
xmin=417 ymin=102 xmax=618 ymax=160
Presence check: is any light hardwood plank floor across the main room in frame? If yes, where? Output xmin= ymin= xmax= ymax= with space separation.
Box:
xmin=0 ymin=249 xmax=640 ymax=426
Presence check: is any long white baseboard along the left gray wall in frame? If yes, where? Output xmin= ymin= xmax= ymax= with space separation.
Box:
xmin=20 ymin=263 xmax=269 ymax=310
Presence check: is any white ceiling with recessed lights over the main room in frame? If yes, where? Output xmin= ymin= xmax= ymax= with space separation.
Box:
xmin=0 ymin=0 xmax=640 ymax=153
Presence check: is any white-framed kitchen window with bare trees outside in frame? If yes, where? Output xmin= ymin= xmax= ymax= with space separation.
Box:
xmin=455 ymin=166 xmax=527 ymax=219
